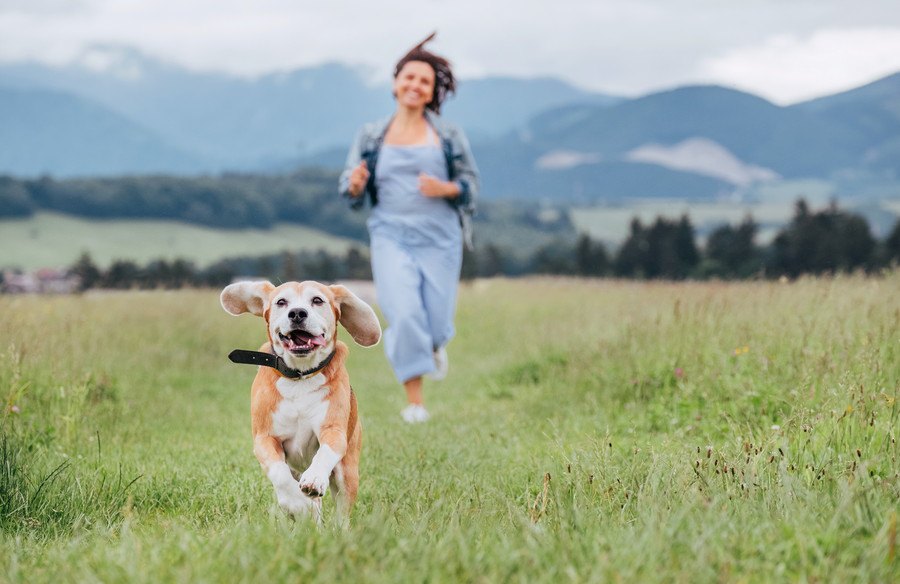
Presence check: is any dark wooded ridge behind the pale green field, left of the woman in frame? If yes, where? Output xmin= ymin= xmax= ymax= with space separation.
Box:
xmin=0 ymin=169 xmax=366 ymax=240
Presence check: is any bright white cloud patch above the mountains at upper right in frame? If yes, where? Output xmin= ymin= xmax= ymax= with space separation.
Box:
xmin=700 ymin=28 xmax=900 ymax=104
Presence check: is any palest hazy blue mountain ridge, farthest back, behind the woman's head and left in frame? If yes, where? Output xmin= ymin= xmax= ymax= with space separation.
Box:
xmin=0 ymin=47 xmax=615 ymax=172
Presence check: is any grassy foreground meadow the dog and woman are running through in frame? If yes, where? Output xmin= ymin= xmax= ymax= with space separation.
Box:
xmin=0 ymin=273 xmax=900 ymax=583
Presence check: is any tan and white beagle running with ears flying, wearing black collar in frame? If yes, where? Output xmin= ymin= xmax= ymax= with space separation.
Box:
xmin=220 ymin=281 xmax=381 ymax=522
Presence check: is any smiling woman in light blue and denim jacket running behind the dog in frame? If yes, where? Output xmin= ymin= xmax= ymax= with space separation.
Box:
xmin=340 ymin=34 xmax=478 ymax=423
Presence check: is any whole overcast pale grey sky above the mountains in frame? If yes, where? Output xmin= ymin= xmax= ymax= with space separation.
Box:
xmin=0 ymin=0 xmax=900 ymax=104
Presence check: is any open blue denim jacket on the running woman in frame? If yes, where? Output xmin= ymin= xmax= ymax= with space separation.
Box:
xmin=339 ymin=110 xmax=478 ymax=250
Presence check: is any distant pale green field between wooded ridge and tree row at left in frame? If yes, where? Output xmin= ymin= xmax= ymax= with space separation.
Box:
xmin=0 ymin=212 xmax=354 ymax=270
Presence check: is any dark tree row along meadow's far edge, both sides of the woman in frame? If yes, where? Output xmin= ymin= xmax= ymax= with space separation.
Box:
xmin=56 ymin=200 xmax=900 ymax=289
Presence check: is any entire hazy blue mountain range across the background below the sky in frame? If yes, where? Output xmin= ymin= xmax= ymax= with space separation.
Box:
xmin=0 ymin=47 xmax=900 ymax=202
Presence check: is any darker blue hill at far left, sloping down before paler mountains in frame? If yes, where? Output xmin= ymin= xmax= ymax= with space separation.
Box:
xmin=0 ymin=87 xmax=197 ymax=175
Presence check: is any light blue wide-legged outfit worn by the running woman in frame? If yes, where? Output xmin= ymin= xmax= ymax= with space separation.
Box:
xmin=367 ymin=126 xmax=462 ymax=383
